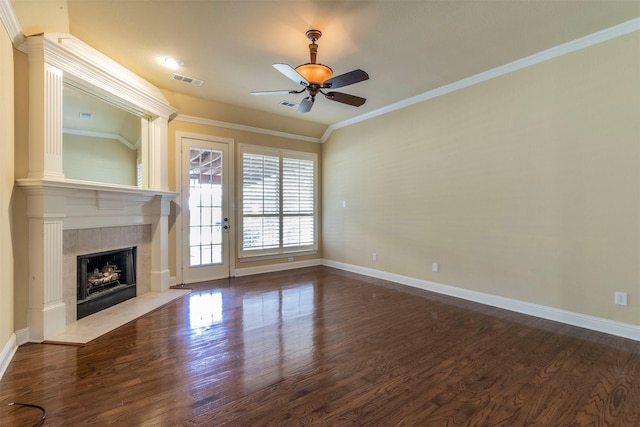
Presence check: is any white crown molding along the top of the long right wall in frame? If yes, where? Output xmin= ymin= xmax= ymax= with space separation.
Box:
xmin=320 ymin=18 xmax=640 ymax=142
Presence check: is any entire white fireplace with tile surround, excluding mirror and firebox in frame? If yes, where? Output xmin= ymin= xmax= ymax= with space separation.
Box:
xmin=17 ymin=31 xmax=179 ymax=343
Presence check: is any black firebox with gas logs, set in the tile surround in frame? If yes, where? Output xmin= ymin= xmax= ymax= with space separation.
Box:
xmin=77 ymin=246 xmax=137 ymax=320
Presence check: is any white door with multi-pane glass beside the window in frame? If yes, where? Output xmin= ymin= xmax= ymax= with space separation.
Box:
xmin=181 ymin=136 xmax=231 ymax=283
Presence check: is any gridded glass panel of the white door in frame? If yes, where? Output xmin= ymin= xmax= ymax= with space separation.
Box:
xmin=189 ymin=147 xmax=223 ymax=267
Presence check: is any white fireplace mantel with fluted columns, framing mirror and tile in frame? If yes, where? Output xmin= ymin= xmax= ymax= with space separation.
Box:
xmin=16 ymin=33 xmax=177 ymax=341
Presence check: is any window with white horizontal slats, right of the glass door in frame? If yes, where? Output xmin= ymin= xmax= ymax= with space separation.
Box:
xmin=240 ymin=145 xmax=317 ymax=258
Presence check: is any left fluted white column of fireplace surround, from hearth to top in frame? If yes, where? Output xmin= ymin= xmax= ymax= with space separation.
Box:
xmin=23 ymin=37 xmax=69 ymax=341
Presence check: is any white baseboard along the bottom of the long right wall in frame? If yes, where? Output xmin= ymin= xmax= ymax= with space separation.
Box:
xmin=322 ymin=259 xmax=640 ymax=341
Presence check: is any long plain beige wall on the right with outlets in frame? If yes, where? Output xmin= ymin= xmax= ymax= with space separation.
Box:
xmin=323 ymin=32 xmax=640 ymax=325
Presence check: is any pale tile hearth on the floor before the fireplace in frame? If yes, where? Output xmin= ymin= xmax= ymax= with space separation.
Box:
xmin=45 ymin=289 xmax=190 ymax=344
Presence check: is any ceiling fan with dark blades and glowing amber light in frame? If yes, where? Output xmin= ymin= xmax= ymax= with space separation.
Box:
xmin=251 ymin=30 xmax=369 ymax=113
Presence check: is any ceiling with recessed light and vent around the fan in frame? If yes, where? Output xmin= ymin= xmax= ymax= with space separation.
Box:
xmin=58 ymin=0 xmax=640 ymax=130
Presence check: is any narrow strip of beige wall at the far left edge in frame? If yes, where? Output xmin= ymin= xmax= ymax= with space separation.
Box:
xmin=0 ymin=17 xmax=14 ymax=351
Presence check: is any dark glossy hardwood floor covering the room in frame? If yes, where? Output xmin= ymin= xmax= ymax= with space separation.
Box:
xmin=0 ymin=267 xmax=640 ymax=427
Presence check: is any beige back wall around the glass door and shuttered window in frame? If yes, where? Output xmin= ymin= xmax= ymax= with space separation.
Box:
xmin=169 ymin=102 xmax=322 ymax=276
